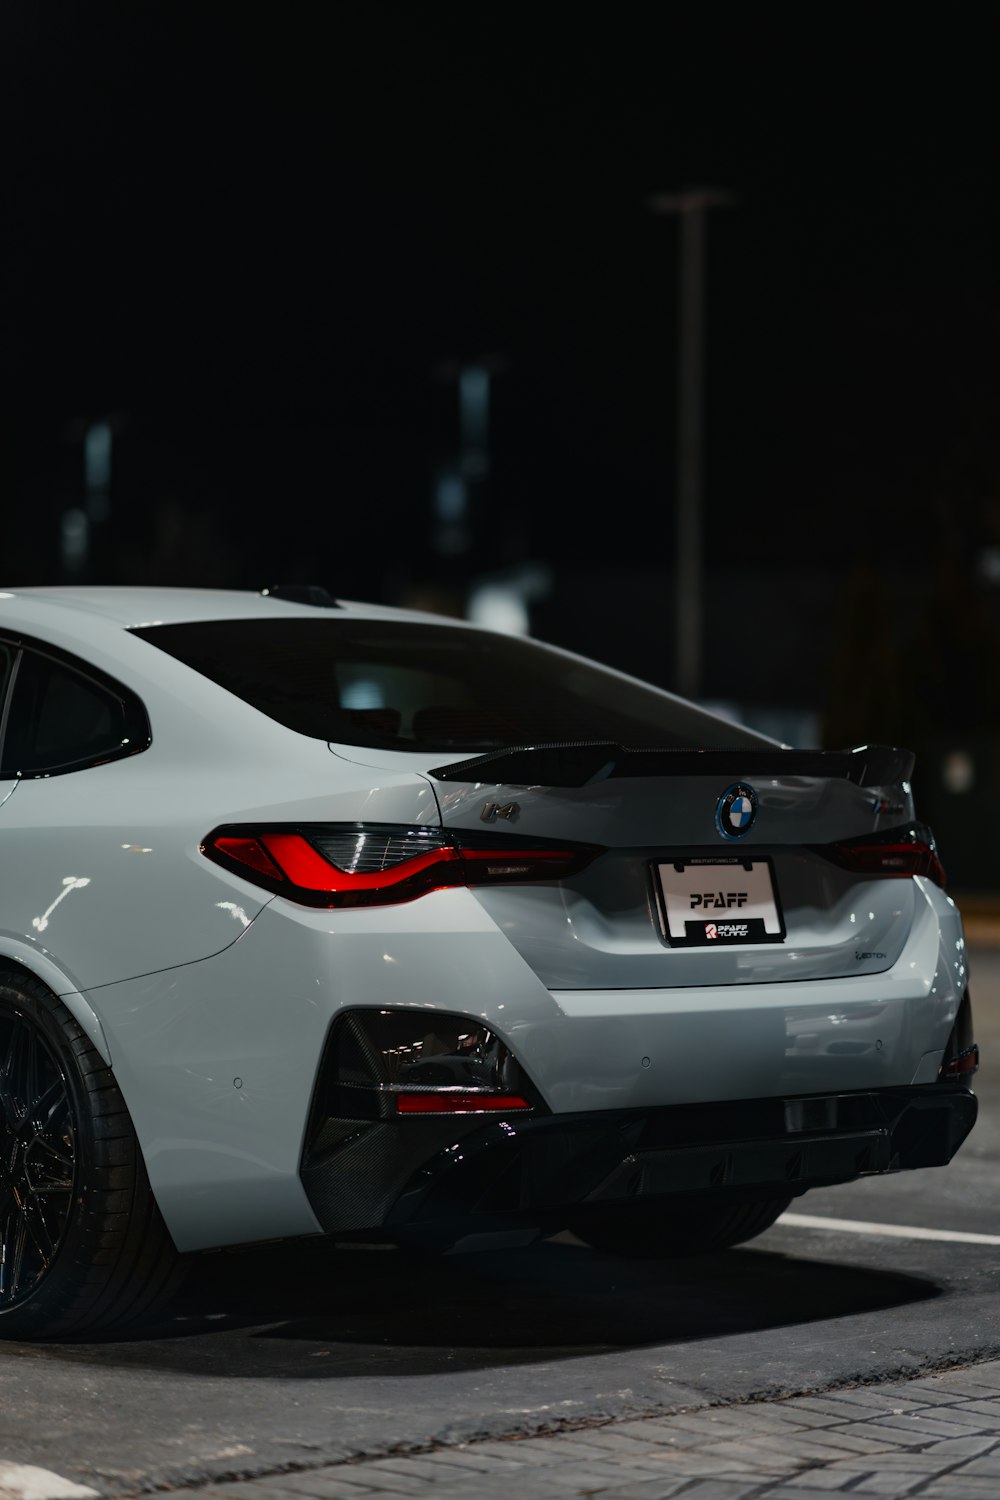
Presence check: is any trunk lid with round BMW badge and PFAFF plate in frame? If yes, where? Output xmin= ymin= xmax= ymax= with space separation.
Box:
xmin=430 ymin=746 xmax=915 ymax=990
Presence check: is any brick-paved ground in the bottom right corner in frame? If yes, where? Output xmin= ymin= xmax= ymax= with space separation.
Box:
xmin=158 ymin=1361 xmax=1000 ymax=1500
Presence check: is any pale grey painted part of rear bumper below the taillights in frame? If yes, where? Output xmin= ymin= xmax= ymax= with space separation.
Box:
xmin=87 ymin=890 xmax=966 ymax=1251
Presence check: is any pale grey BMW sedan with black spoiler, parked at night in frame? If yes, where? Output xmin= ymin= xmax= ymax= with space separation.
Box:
xmin=0 ymin=587 xmax=978 ymax=1337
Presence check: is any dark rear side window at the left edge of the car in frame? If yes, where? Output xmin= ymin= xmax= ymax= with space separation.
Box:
xmin=0 ymin=648 xmax=148 ymax=776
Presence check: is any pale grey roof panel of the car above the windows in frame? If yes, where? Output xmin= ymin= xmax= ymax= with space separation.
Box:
xmin=0 ymin=584 xmax=449 ymax=630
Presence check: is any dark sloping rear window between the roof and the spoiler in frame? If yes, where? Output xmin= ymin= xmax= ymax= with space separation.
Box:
xmin=135 ymin=618 xmax=759 ymax=752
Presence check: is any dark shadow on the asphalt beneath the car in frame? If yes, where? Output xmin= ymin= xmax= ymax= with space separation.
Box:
xmin=33 ymin=1239 xmax=940 ymax=1379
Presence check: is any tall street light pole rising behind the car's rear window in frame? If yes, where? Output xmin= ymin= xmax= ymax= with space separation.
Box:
xmin=648 ymin=188 xmax=735 ymax=698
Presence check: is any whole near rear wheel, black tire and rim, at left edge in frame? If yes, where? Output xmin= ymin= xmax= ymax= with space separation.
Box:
xmin=0 ymin=972 xmax=181 ymax=1338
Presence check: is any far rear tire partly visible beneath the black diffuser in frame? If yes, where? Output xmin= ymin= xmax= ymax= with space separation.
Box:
xmin=573 ymin=1199 xmax=792 ymax=1260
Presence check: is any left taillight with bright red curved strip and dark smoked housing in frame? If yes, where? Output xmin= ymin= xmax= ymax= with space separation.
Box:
xmin=201 ymin=824 xmax=601 ymax=906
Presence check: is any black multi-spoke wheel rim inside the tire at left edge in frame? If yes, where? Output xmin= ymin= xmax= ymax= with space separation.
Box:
xmin=0 ymin=1013 xmax=76 ymax=1311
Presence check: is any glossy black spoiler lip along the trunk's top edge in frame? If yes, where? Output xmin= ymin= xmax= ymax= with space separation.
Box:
xmin=429 ymin=740 xmax=915 ymax=786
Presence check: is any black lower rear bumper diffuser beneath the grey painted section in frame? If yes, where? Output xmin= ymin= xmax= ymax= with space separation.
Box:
xmin=303 ymin=1085 xmax=978 ymax=1242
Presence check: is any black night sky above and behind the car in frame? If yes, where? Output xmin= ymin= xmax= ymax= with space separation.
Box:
xmin=0 ymin=0 xmax=1000 ymax=860
